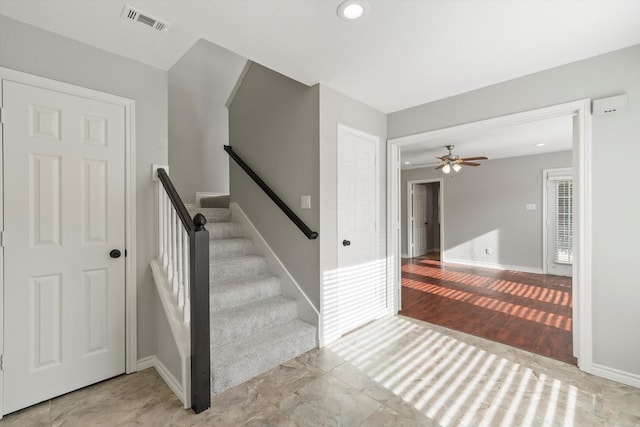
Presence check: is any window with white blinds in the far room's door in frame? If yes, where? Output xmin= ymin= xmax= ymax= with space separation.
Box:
xmin=555 ymin=180 xmax=573 ymax=264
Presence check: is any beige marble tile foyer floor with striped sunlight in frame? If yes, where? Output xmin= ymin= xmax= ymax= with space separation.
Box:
xmin=0 ymin=316 xmax=640 ymax=427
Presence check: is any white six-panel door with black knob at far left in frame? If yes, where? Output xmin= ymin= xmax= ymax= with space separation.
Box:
xmin=2 ymin=80 xmax=125 ymax=414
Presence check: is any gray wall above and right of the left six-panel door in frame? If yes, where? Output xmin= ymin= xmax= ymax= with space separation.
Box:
xmin=0 ymin=15 xmax=167 ymax=364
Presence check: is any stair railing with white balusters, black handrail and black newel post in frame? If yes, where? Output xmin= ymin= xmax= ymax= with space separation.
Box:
xmin=157 ymin=168 xmax=211 ymax=413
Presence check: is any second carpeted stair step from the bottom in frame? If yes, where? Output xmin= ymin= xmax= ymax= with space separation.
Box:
xmin=211 ymin=296 xmax=298 ymax=348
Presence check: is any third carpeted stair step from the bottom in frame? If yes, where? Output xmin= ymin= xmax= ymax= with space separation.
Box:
xmin=209 ymin=275 xmax=281 ymax=313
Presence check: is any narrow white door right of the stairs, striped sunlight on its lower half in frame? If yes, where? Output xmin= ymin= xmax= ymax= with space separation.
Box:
xmin=337 ymin=126 xmax=387 ymax=333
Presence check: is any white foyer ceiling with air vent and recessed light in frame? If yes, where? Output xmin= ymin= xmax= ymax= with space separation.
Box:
xmin=0 ymin=0 xmax=640 ymax=113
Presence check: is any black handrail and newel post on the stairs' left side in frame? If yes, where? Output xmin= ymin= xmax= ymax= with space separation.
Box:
xmin=158 ymin=168 xmax=211 ymax=414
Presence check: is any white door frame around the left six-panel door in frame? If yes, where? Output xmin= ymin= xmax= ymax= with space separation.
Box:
xmin=0 ymin=67 xmax=138 ymax=419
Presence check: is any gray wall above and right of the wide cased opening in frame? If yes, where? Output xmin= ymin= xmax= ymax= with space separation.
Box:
xmin=388 ymin=45 xmax=640 ymax=375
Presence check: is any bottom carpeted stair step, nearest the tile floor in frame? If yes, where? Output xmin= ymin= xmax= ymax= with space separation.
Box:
xmin=211 ymin=319 xmax=317 ymax=394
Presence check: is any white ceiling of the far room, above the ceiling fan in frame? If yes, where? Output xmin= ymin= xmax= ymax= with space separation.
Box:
xmin=401 ymin=116 xmax=573 ymax=169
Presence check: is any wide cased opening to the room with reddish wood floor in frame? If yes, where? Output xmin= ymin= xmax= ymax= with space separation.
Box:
xmin=392 ymin=110 xmax=577 ymax=364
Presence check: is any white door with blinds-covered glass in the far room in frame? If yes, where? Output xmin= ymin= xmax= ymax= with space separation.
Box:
xmin=545 ymin=170 xmax=573 ymax=277
